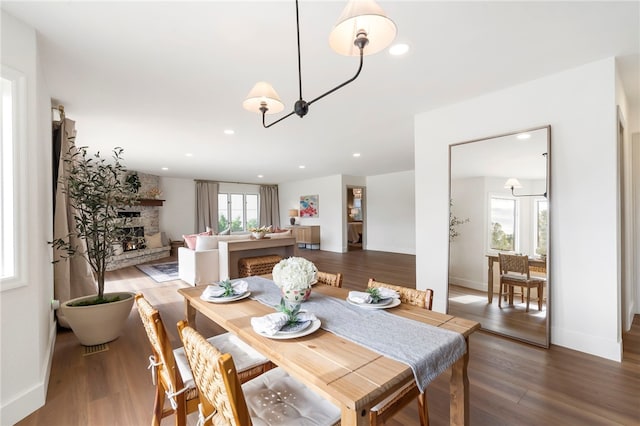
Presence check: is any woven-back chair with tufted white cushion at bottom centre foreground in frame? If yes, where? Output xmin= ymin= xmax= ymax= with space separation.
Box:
xmin=178 ymin=321 xmax=341 ymax=426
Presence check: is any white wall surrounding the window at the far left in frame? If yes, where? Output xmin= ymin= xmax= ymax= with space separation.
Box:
xmin=0 ymin=11 xmax=55 ymax=425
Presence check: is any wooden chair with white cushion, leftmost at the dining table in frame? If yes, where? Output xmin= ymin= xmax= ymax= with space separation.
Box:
xmin=135 ymin=294 xmax=274 ymax=426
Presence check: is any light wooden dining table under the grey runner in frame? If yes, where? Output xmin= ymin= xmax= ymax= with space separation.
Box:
xmin=178 ymin=284 xmax=480 ymax=426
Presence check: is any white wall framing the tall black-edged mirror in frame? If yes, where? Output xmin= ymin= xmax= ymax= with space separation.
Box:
xmin=415 ymin=58 xmax=622 ymax=360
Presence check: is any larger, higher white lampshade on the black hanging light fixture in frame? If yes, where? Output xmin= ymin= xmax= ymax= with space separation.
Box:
xmin=329 ymin=0 xmax=397 ymax=56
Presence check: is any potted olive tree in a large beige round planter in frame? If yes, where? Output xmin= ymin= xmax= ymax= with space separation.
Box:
xmin=51 ymin=140 xmax=137 ymax=346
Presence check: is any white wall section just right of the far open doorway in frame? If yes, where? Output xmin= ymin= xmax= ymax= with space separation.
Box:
xmin=366 ymin=170 xmax=416 ymax=254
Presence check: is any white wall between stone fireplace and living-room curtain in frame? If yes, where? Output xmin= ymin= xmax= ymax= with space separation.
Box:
xmin=160 ymin=177 xmax=194 ymax=241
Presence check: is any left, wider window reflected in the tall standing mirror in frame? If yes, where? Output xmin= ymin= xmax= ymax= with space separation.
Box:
xmin=489 ymin=196 xmax=518 ymax=251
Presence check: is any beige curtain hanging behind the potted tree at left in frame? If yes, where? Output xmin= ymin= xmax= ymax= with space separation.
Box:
xmin=53 ymin=118 xmax=98 ymax=327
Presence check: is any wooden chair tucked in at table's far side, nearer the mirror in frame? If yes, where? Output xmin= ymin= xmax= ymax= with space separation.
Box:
xmin=367 ymin=278 xmax=433 ymax=426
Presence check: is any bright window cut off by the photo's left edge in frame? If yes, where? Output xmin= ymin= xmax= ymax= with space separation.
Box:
xmin=0 ymin=65 xmax=26 ymax=290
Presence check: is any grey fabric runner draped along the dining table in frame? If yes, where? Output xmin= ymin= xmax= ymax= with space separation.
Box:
xmin=243 ymin=277 xmax=466 ymax=392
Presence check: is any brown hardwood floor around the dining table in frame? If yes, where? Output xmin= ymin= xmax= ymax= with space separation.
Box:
xmin=18 ymin=250 xmax=640 ymax=426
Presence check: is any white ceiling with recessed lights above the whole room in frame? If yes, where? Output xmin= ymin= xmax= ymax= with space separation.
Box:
xmin=1 ymin=0 xmax=640 ymax=183
